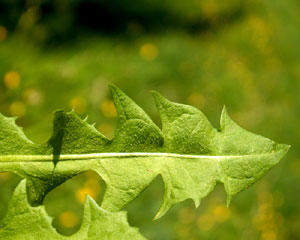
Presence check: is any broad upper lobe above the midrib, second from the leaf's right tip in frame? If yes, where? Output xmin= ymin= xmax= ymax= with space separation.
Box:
xmin=152 ymin=92 xmax=217 ymax=155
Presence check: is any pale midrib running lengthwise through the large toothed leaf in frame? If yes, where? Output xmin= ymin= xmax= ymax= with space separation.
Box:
xmin=0 ymin=152 xmax=274 ymax=163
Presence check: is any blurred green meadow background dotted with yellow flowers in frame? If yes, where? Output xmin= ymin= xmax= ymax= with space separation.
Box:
xmin=0 ymin=0 xmax=300 ymax=240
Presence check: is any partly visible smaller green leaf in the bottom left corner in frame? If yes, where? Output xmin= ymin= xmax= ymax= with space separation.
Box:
xmin=0 ymin=180 xmax=145 ymax=240
